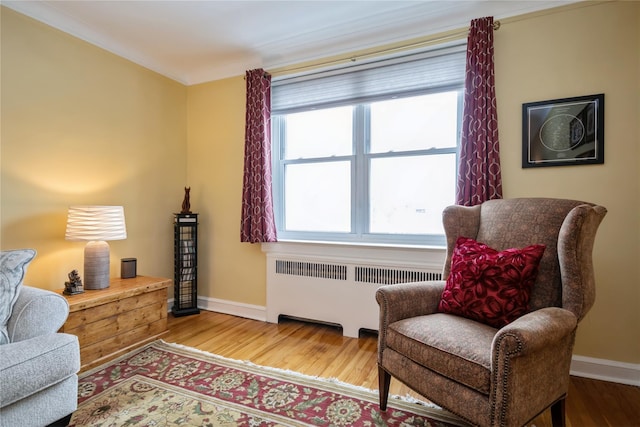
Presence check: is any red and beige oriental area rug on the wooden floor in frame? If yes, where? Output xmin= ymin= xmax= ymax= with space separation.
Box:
xmin=70 ymin=340 xmax=465 ymax=427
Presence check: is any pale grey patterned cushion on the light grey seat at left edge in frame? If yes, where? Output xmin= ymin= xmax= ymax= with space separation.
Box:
xmin=0 ymin=249 xmax=36 ymax=344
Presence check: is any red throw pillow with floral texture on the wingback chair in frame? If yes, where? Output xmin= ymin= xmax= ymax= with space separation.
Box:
xmin=438 ymin=237 xmax=545 ymax=328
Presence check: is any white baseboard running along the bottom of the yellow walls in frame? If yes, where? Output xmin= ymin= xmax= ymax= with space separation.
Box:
xmin=167 ymin=297 xmax=640 ymax=387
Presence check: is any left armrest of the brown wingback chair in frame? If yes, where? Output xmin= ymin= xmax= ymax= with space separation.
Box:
xmin=376 ymin=280 xmax=445 ymax=330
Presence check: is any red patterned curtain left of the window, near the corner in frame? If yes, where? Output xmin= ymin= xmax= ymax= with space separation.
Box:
xmin=240 ymin=68 xmax=277 ymax=243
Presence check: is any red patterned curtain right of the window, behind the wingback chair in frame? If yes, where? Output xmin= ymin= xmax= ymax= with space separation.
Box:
xmin=456 ymin=17 xmax=502 ymax=206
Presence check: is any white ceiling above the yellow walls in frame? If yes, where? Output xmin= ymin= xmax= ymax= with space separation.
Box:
xmin=2 ymin=0 xmax=578 ymax=85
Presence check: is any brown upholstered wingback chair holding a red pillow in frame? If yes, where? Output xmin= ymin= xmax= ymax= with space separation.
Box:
xmin=376 ymin=198 xmax=607 ymax=427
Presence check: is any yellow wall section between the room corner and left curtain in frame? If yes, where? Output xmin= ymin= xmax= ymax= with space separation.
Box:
xmin=187 ymin=76 xmax=266 ymax=306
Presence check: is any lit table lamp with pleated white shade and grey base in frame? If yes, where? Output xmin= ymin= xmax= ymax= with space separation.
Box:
xmin=65 ymin=206 xmax=127 ymax=289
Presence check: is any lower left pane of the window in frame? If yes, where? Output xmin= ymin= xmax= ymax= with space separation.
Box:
xmin=285 ymin=162 xmax=351 ymax=233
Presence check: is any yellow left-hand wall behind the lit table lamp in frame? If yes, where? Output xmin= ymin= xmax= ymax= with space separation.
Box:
xmin=0 ymin=8 xmax=187 ymax=290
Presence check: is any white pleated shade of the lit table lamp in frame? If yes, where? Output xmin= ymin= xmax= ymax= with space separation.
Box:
xmin=65 ymin=206 xmax=127 ymax=241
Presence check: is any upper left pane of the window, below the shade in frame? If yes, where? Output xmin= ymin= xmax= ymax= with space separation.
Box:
xmin=285 ymin=106 xmax=353 ymax=159
